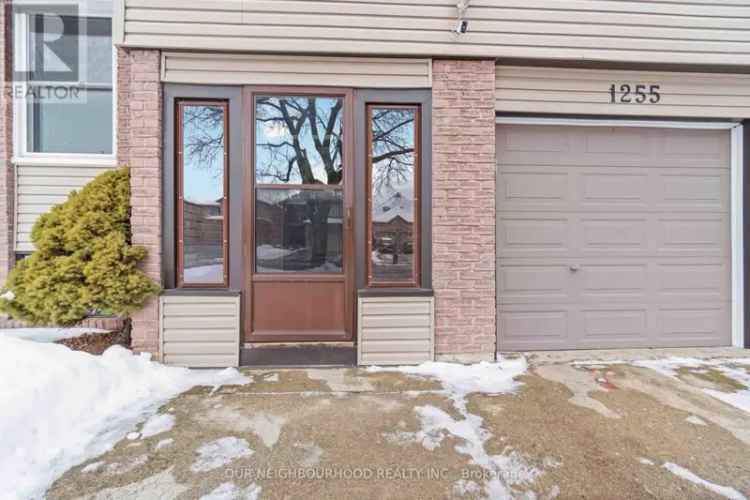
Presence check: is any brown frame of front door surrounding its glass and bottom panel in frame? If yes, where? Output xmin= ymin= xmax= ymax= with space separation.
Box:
xmin=242 ymin=86 xmax=355 ymax=342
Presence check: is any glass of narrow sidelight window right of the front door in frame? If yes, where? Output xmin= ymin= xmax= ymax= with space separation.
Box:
xmin=369 ymin=106 xmax=418 ymax=285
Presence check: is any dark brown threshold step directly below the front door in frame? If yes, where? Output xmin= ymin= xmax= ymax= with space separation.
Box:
xmin=240 ymin=342 xmax=357 ymax=368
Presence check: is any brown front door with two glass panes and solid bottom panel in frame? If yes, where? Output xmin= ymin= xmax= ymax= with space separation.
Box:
xmin=245 ymin=88 xmax=353 ymax=342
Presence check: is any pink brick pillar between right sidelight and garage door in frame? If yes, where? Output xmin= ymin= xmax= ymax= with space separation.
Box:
xmin=432 ymin=60 xmax=496 ymax=362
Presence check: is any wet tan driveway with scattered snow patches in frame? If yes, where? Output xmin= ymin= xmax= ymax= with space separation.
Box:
xmin=48 ymin=349 xmax=750 ymax=499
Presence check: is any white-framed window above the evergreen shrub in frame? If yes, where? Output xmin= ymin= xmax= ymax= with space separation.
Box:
xmin=14 ymin=1 xmax=114 ymax=158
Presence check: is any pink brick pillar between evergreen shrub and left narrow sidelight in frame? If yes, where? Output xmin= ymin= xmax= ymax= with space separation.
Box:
xmin=117 ymin=48 xmax=162 ymax=355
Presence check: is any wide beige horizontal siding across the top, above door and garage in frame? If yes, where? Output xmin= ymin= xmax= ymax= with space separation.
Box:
xmin=115 ymin=0 xmax=750 ymax=65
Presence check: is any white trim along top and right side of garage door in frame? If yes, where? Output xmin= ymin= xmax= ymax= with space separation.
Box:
xmin=495 ymin=116 xmax=745 ymax=347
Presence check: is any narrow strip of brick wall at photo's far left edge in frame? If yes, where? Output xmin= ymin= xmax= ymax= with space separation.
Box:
xmin=0 ymin=1 xmax=16 ymax=286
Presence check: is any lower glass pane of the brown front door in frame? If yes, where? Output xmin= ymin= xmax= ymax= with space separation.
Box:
xmin=255 ymin=188 xmax=343 ymax=273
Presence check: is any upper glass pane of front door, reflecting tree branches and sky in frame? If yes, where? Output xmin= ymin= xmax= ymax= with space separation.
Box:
xmin=255 ymin=96 xmax=344 ymax=185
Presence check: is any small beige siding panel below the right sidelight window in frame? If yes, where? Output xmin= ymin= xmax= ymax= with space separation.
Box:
xmin=357 ymin=297 xmax=434 ymax=365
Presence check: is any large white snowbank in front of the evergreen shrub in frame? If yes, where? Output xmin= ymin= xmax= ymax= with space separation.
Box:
xmin=0 ymin=336 xmax=249 ymax=499
